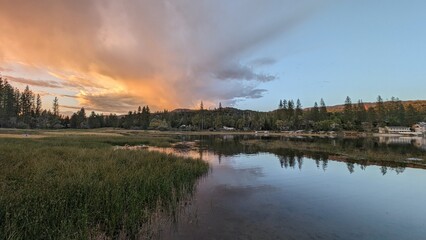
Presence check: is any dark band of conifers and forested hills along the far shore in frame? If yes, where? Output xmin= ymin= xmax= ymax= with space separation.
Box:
xmin=0 ymin=76 xmax=426 ymax=131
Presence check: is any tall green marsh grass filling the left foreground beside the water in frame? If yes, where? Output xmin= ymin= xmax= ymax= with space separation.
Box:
xmin=0 ymin=136 xmax=208 ymax=239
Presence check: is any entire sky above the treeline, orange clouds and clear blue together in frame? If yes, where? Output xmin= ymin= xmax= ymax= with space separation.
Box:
xmin=0 ymin=0 xmax=426 ymax=113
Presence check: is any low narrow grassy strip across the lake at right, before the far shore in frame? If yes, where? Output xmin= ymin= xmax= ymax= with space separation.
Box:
xmin=242 ymin=139 xmax=426 ymax=169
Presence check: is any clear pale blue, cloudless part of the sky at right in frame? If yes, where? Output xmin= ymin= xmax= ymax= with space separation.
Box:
xmin=238 ymin=1 xmax=426 ymax=109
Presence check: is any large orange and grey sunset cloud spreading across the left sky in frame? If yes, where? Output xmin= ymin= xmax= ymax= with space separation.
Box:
xmin=0 ymin=0 xmax=315 ymax=112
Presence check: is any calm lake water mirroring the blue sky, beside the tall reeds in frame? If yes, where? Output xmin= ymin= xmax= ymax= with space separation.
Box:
xmin=156 ymin=136 xmax=426 ymax=240
